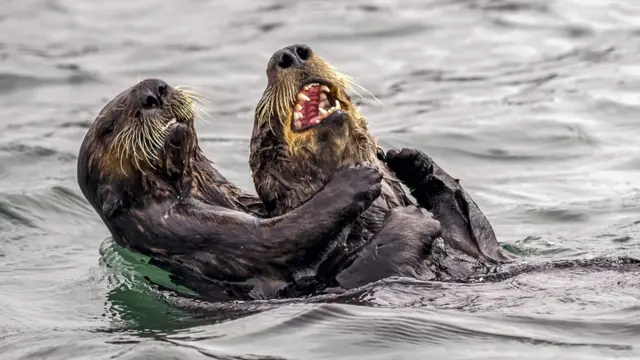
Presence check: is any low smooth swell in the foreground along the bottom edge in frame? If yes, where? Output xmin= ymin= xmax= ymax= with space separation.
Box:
xmin=158 ymin=304 xmax=634 ymax=359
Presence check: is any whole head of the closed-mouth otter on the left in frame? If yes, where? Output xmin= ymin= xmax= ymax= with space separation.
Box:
xmin=78 ymin=79 xmax=198 ymax=215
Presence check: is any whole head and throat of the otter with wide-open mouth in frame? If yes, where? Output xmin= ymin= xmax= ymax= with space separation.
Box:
xmin=252 ymin=45 xmax=376 ymax=171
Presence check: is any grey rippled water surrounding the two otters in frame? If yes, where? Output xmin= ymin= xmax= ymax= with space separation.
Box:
xmin=0 ymin=0 xmax=640 ymax=360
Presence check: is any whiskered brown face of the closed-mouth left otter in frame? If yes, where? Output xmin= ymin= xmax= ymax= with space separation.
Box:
xmin=85 ymin=79 xmax=197 ymax=177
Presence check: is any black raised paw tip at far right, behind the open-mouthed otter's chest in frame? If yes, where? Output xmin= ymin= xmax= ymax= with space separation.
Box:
xmin=385 ymin=148 xmax=434 ymax=188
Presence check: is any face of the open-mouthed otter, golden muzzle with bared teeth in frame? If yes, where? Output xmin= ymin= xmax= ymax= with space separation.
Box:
xmin=256 ymin=45 xmax=364 ymax=152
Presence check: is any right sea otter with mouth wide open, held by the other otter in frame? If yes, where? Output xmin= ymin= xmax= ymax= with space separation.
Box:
xmin=249 ymin=45 xmax=512 ymax=288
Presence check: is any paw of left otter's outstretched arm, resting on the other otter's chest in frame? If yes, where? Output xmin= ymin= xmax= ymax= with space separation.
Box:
xmin=330 ymin=163 xmax=383 ymax=213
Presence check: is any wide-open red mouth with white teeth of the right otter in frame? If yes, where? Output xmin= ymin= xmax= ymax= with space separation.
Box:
xmin=291 ymin=82 xmax=341 ymax=131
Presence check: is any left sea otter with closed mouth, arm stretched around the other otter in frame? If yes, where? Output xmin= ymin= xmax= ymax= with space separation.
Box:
xmin=77 ymin=79 xmax=382 ymax=300
